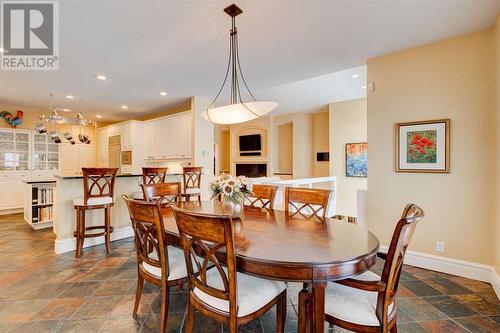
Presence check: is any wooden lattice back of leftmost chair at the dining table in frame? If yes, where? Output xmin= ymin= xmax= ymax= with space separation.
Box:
xmin=122 ymin=194 xmax=169 ymax=279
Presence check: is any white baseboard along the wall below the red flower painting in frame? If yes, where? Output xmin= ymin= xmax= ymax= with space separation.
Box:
xmin=379 ymin=245 xmax=500 ymax=299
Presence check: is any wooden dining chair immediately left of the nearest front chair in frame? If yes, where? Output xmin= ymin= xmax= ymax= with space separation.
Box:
xmin=122 ymin=195 xmax=187 ymax=333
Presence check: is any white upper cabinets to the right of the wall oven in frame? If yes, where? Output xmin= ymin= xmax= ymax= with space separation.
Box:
xmin=144 ymin=112 xmax=192 ymax=160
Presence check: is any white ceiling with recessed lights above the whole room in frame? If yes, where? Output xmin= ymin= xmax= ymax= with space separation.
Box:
xmin=0 ymin=0 xmax=500 ymax=119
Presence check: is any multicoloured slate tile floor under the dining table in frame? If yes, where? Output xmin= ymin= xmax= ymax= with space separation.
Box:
xmin=0 ymin=215 xmax=500 ymax=333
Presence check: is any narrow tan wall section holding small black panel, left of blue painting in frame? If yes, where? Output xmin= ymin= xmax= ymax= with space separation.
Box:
xmin=313 ymin=110 xmax=330 ymax=177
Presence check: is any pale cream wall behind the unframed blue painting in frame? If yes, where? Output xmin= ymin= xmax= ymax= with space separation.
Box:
xmin=329 ymin=98 xmax=373 ymax=216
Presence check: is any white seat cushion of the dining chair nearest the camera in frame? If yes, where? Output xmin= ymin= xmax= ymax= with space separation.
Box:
xmin=193 ymin=268 xmax=286 ymax=317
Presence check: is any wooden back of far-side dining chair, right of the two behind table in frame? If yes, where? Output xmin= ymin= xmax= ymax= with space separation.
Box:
xmin=285 ymin=187 xmax=331 ymax=222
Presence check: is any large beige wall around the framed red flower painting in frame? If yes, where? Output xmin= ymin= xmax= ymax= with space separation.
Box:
xmin=367 ymin=29 xmax=498 ymax=265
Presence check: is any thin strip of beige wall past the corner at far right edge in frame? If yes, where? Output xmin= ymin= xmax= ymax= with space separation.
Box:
xmin=493 ymin=15 xmax=500 ymax=276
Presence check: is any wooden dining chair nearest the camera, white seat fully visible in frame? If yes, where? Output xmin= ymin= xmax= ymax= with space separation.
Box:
xmin=171 ymin=206 xmax=286 ymax=333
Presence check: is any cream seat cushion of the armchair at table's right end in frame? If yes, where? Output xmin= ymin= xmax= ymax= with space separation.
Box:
xmin=325 ymin=271 xmax=394 ymax=326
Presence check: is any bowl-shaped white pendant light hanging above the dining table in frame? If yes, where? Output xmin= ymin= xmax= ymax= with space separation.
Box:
xmin=201 ymin=4 xmax=278 ymax=125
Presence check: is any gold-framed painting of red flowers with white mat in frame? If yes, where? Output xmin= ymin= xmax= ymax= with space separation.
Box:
xmin=396 ymin=119 xmax=450 ymax=173
